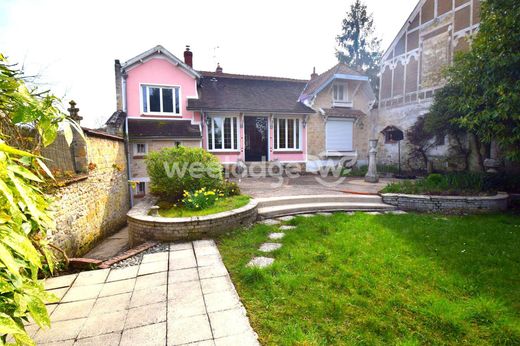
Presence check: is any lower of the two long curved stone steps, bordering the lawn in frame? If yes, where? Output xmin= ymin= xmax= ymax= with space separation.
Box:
xmin=258 ymin=201 xmax=396 ymax=219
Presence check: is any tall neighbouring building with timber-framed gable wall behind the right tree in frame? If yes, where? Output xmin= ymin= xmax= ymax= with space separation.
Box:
xmin=371 ymin=0 xmax=480 ymax=168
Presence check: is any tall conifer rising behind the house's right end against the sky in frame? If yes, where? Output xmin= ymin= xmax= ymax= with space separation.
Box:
xmin=336 ymin=0 xmax=382 ymax=95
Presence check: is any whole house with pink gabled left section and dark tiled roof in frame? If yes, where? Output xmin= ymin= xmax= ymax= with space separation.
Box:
xmin=106 ymin=46 xmax=375 ymax=197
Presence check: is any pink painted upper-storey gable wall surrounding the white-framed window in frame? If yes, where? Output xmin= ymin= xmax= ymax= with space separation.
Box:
xmin=126 ymin=57 xmax=200 ymax=123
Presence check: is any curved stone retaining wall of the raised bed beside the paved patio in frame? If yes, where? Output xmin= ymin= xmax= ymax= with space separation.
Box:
xmin=127 ymin=198 xmax=258 ymax=247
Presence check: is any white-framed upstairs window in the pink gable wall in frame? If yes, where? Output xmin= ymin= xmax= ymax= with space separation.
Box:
xmin=141 ymin=85 xmax=181 ymax=115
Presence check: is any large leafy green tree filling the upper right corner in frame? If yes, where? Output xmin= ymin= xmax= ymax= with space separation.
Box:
xmin=432 ymin=0 xmax=520 ymax=161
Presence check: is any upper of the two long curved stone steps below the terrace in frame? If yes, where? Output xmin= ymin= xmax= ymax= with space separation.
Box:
xmin=256 ymin=194 xmax=383 ymax=208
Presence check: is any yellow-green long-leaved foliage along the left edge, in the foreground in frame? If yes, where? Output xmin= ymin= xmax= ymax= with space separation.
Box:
xmin=0 ymin=54 xmax=81 ymax=345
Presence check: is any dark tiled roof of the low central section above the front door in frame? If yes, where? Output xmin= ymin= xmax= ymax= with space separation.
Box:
xmin=188 ymin=72 xmax=314 ymax=114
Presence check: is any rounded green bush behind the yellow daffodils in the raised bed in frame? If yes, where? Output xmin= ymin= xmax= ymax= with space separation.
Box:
xmin=146 ymin=146 xmax=223 ymax=202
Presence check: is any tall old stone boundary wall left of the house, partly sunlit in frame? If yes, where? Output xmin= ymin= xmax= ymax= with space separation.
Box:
xmin=50 ymin=130 xmax=130 ymax=256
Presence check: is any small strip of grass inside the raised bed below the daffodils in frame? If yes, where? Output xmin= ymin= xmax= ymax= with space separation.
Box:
xmin=159 ymin=195 xmax=250 ymax=217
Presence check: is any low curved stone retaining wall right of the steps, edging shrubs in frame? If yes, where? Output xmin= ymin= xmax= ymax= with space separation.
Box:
xmin=381 ymin=192 xmax=509 ymax=214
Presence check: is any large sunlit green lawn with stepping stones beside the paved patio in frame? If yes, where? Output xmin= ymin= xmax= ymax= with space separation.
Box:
xmin=219 ymin=213 xmax=520 ymax=345
